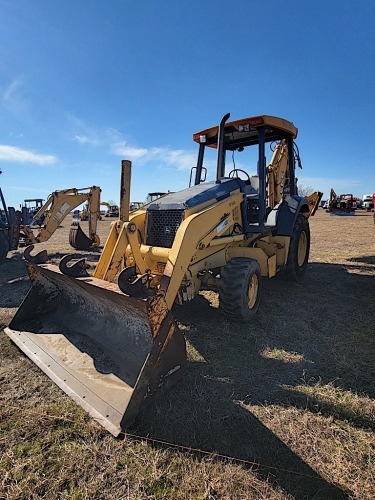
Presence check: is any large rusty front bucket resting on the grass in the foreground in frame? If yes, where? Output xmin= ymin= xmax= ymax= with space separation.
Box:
xmin=5 ymin=262 xmax=186 ymax=436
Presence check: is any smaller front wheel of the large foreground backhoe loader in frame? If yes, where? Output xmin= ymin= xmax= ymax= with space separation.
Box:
xmin=219 ymin=257 xmax=262 ymax=323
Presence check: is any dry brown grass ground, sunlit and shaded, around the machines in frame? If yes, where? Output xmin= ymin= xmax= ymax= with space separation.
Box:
xmin=0 ymin=210 xmax=375 ymax=500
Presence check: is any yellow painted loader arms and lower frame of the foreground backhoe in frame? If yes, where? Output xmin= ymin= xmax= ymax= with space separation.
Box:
xmin=94 ymin=190 xmax=290 ymax=308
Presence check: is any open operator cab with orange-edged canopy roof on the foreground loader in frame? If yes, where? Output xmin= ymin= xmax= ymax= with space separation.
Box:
xmin=192 ymin=114 xmax=299 ymax=232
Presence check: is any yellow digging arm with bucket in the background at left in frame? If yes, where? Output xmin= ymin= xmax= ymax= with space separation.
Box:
xmin=19 ymin=186 xmax=101 ymax=250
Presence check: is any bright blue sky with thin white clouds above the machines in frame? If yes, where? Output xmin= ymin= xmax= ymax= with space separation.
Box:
xmin=0 ymin=0 xmax=375 ymax=207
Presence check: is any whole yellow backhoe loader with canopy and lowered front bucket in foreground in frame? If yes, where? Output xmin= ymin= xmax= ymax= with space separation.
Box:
xmin=6 ymin=114 xmax=318 ymax=435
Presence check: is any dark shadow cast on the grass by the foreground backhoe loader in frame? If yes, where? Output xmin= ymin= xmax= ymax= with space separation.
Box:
xmin=129 ymin=264 xmax=375 ymax=499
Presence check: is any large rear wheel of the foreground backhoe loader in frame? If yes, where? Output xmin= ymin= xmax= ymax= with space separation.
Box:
xmin=281 ymin=214 xmax=310 ymax=280
